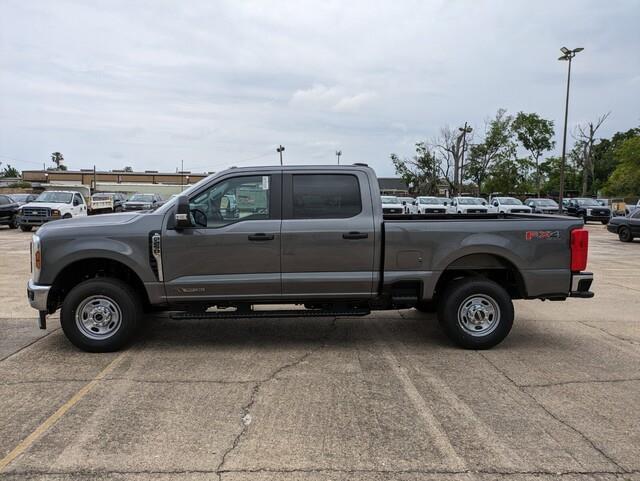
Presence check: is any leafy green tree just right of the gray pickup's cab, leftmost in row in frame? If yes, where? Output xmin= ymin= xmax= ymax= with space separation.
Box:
xmin=391 ymin=142 xmax=438 ymax=195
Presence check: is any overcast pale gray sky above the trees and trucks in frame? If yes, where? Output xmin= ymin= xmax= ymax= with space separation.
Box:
xmin=0 ymin=0 xmax=640 ymax=175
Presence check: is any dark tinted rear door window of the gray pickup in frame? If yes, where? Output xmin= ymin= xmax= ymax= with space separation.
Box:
xmin=292 ymin=174 xmax=362 ymax=219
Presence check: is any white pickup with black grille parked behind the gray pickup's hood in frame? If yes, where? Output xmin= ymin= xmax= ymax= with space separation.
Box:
xmin=17 ymin=190 xmax=87 ymax=232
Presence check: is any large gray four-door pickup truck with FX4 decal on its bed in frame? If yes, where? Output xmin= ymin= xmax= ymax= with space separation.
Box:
xmin=27 ymin=164 xmax=593 ymax=352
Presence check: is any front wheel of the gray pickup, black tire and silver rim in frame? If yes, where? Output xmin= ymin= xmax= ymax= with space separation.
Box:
xmin=60 ymin=278 xmax=142 ymax=352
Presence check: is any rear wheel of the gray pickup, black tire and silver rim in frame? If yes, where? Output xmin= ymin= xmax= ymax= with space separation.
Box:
xmin=438 ymin=277 xmax=514 ymax=349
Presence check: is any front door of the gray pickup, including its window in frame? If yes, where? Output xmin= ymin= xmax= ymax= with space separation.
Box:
xmin=162 ymin=172 xmax=282 ymax=301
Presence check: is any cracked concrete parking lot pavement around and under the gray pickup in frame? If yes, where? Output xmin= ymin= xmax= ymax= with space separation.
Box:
xmin=0 ymin=225 xmax=640 ymax=481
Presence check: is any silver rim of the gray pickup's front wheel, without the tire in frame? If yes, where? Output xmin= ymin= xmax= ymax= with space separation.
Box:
xmin=76 ymin=295 xmax=122 ymax=340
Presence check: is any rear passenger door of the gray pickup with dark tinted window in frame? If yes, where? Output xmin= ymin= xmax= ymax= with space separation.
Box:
xmin=282 ymin=171 xmax=375 ymax=298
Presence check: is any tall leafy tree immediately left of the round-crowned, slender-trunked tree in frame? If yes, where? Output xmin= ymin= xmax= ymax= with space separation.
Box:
xmin=465 ymin=109 xmax=513 ymax=193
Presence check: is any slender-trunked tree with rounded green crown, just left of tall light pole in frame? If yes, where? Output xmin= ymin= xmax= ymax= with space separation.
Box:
xmin=511 ymin=112 xmax=555 ymax=197
